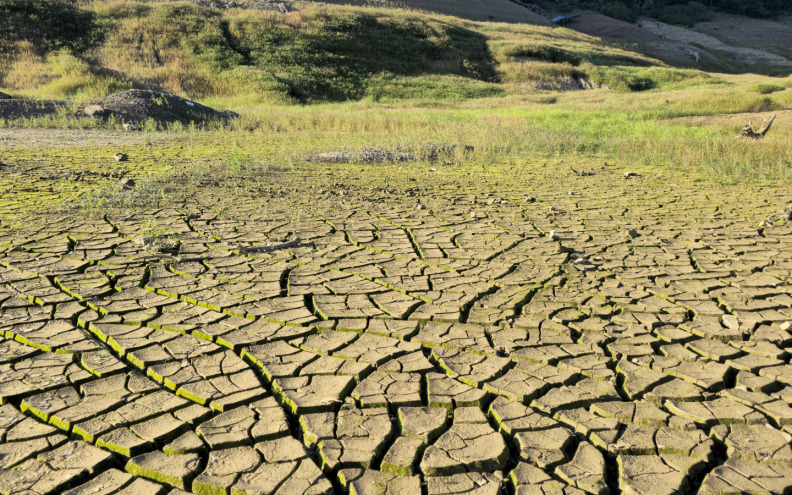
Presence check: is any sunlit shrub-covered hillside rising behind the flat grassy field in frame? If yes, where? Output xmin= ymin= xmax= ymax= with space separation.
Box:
xmin=0 ymin=0 xmax=707 ymax=102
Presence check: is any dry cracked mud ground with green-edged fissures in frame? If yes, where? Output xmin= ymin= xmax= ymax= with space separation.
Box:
xmin=0 ymin=130 xmax=792 ymax=495
